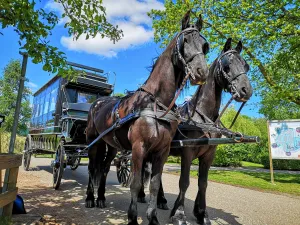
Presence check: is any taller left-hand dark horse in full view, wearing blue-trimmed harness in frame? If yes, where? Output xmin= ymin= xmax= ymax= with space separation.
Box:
xmin=86 ymin=12 xmax=209 ymax=225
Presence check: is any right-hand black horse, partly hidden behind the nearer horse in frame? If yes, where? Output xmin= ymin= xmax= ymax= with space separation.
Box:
xmin=139 ymin=38 xmax=252 ymax=224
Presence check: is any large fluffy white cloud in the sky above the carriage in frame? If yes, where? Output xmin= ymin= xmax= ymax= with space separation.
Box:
xmin=46 ymin=0 xmax=164 ymax=57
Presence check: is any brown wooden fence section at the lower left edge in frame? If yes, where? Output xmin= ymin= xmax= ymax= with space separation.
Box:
xmin=0 ymin=153 xmax=22 ymax=217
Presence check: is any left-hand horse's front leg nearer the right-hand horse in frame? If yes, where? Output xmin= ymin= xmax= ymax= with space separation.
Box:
xmin=146 ymin=149 xmax=169 ymax=225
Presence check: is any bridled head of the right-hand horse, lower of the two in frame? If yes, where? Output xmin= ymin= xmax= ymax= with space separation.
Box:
xmin=216 ymin=38 xmax=253 ymax=102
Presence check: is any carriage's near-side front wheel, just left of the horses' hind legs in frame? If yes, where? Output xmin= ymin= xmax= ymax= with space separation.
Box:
xmin=53 ymin=142 xmax=65 ymax=190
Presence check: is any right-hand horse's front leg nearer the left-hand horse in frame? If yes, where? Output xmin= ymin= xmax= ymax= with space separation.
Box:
xmin=170 ymin=149 xmax=193 ymax=224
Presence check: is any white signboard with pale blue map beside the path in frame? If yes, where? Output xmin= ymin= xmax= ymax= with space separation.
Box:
xmin=268 ymin=120 xmax=300 ymax=159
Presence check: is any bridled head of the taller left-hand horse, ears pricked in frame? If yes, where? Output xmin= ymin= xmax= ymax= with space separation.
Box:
xmin=173 ymin=11 xmax=209 ymax=85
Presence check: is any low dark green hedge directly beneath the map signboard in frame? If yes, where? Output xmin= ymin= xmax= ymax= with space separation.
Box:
xmin=261 ymin=154 xmax=300 ymax=170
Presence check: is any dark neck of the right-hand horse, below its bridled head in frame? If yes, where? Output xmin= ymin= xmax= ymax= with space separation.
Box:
xmin=191 ymin=63 xmax=222 ymax=121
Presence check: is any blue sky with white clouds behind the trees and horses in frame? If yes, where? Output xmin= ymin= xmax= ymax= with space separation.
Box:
xmin=0 ymin=0 xmax=262 ymax=117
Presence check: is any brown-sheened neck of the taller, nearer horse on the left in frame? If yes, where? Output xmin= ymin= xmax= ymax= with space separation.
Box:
xmin=145 ymin=40 xmax=180 ymax=105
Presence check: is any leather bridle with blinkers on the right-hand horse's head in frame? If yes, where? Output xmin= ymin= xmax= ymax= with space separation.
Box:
xmin=216 ymin=49 xmax=246 ymax=98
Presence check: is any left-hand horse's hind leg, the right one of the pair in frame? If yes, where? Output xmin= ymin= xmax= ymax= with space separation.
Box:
xmin=96 ymin=146 xmax=117 ymax=208
